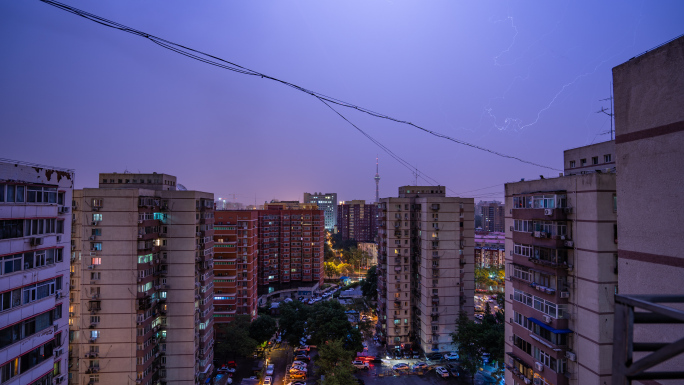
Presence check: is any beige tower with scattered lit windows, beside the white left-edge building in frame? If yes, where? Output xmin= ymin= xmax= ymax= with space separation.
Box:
xmin=69 ymin=173 xmax=214 ymax=385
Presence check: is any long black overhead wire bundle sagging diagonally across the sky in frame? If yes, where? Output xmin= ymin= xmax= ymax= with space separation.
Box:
xmin=39 ymin=0 xmax=562 ymax=171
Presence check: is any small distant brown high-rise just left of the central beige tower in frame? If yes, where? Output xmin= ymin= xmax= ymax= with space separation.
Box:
xmin=337 ymin=200 xmax=378 ymax=242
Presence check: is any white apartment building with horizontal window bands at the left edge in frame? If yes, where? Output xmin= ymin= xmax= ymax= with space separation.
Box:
xmin=0 ymin=160 xmax=74 ymax=385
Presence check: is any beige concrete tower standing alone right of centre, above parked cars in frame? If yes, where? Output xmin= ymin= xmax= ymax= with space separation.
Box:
xmin=378 ymin=186 xmax=474 ymax=352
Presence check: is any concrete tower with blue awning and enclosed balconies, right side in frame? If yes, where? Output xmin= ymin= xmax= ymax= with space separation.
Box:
xmin=505 ymin=142 xmax=617 ymax=385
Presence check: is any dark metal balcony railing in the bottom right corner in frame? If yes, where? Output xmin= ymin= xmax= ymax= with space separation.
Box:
xmin=612 ymin=295 xmax=684 ymax=385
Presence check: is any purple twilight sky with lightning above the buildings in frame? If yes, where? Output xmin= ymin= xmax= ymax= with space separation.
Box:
xmin=0 ymin=0 xmax=684 ymax=204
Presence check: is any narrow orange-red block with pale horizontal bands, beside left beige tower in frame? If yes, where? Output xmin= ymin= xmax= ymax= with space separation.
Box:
xmin=214 ymin=210 xmax=259 ymax=327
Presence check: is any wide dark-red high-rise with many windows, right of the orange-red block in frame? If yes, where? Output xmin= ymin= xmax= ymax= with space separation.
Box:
xmin=257 ymin=205 xmax=325 ymax=285
